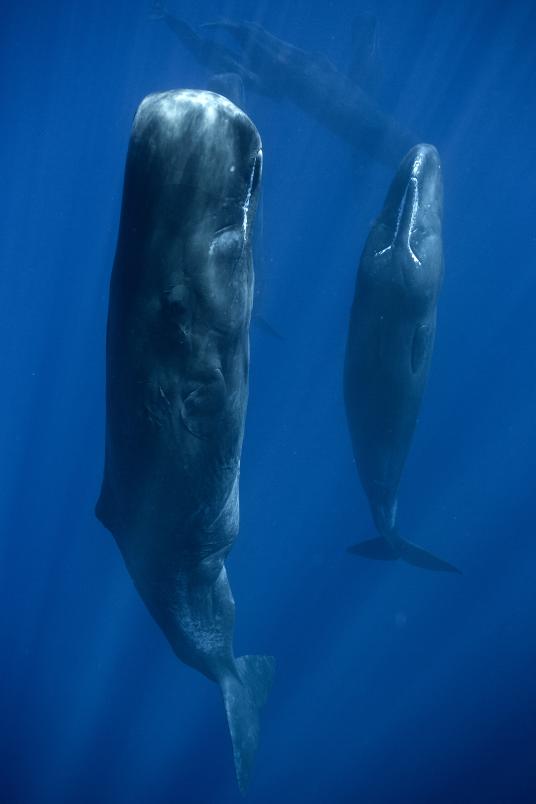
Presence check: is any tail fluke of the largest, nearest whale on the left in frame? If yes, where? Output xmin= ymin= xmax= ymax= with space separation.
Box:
xmin=221 ymin=656 xmax=275 ymax=793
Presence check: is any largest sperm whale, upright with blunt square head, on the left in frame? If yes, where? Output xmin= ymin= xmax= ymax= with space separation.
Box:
xmin=96 ymin=90 xmax=271 ymax=787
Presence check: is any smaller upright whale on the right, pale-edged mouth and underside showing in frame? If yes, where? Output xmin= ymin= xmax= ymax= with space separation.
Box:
xmin=344 ymin=145 xmax=454 ymax=571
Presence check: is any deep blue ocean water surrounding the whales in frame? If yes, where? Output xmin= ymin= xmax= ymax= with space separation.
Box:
xmin=0 ymin=0 xmax=536 ymax=804
